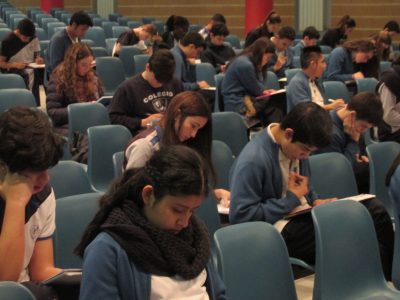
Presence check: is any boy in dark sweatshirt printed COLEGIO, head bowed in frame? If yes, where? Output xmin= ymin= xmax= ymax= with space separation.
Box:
xmin=108 ymin=49 xmax=183 ymax=136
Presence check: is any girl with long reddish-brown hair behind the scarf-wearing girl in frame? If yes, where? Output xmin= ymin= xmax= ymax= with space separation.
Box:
xmin=125 ymin=92 xmax=230 ymax=201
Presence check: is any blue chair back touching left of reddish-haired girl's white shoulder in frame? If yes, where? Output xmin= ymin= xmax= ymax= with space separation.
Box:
xmin=87 ymin=125 xmax=132 ymax=191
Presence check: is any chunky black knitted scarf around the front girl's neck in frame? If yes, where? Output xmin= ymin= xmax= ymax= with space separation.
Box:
xmin=101 ymin=199 xmax=210 ymax=280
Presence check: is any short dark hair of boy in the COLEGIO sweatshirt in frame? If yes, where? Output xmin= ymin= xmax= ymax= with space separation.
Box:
xmin=149 ymin=49 xmax=175 ymax=83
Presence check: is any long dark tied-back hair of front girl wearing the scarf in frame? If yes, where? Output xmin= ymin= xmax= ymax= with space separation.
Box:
xmin=75 ymin=145 xmax=209 ymax=256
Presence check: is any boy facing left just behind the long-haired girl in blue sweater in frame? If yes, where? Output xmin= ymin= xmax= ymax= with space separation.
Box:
xmin=268 ymin=26 xmax=296 ymax=78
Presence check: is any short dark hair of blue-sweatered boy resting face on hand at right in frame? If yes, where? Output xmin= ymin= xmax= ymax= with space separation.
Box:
xmin=347 ymin=92 xmax=383 ymax=126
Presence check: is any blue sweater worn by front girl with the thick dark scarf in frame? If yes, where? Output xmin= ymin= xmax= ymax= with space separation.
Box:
xmin=79 ymin=232 xmax=226 ymax=300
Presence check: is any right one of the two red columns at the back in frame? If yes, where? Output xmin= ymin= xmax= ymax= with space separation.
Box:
xmin=245 ymin=0 xmax=274 ymax=34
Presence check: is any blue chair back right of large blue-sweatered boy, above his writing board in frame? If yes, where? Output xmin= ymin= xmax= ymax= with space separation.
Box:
xmin=309 ymin=152 xmax=358 ymax=199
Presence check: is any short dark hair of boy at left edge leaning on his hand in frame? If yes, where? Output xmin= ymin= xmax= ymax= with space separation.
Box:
xmin=0 ymin=106 xmax=65 ymax=173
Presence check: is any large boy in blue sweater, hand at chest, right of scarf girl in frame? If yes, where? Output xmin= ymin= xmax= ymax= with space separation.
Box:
xmin=229 ymin=102 xmax=393 ymax=279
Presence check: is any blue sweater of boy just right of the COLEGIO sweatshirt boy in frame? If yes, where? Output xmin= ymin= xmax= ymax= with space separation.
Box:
xmin=170 ymin=45 xmax=199 ymax=91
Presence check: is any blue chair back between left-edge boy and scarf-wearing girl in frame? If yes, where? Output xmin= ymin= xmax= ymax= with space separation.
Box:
xmin=54 ymin=193 xmax=101 ymax=269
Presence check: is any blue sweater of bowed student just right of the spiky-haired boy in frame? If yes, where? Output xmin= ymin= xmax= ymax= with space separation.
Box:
xmin=326 ymin=47 xmax=354 ymax=81
